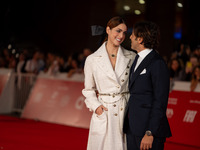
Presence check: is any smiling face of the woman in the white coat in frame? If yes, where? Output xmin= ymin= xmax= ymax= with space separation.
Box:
xmin=106 ymin=24 xmax=127 ymax=47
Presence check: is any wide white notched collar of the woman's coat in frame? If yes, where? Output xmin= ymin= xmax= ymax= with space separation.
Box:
xmin=94 ymin=42 xmax=130 ymax=82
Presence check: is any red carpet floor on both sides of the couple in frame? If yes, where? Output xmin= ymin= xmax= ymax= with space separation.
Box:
xmin=0 ymin=115 xmax=200 ymax=150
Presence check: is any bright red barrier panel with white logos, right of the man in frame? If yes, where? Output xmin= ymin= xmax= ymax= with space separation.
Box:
xmin=167 ymin=90 xmax=200 ymax=149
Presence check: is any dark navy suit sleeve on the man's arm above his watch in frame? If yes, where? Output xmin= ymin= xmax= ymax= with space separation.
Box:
xmin=148 ymin=59 xmax=169 ymax=135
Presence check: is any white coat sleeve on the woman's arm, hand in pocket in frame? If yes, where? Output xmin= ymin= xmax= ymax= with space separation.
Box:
xmin=82 ymin=56 xmax=101 ymax=112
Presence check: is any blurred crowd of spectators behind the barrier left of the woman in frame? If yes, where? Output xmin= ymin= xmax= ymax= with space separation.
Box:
xmin=0 ymin=45 xmax=91 ymax=77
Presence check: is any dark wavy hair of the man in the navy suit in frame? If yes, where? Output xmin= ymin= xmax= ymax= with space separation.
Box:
xmin=133 ymin=21 xmax=160 ymax=49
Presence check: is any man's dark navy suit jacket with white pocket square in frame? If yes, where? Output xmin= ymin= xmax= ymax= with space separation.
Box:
xmin=123 ymin=50 xmax=171 ymax=137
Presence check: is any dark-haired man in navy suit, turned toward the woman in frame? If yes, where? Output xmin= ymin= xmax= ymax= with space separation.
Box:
xmin=123 ymin=22 xmax=171 ymax=150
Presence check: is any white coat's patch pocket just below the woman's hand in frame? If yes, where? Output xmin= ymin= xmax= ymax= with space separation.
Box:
xmin=90 ymin=112 xmax=107 ymax=135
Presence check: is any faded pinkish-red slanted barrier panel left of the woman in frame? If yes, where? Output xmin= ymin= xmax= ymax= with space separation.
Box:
xmin=22 ymin=75 xmax=91 ymax=128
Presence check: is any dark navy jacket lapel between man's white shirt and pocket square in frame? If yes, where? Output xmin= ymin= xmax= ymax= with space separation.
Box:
xmin=129 ymin=50 xmax=156 ymax=88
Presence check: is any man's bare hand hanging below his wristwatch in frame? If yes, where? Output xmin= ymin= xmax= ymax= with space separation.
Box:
xmin=140 ymin=134 xmax=153 ymax=150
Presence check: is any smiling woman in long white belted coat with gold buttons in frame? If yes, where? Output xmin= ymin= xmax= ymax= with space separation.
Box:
xmin=82 ymin=17 xmax=135 ymax=150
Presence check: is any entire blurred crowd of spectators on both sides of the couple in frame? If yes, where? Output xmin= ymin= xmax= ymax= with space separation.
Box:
xmin=0 ymin=40 xmax=200 ymax=91
